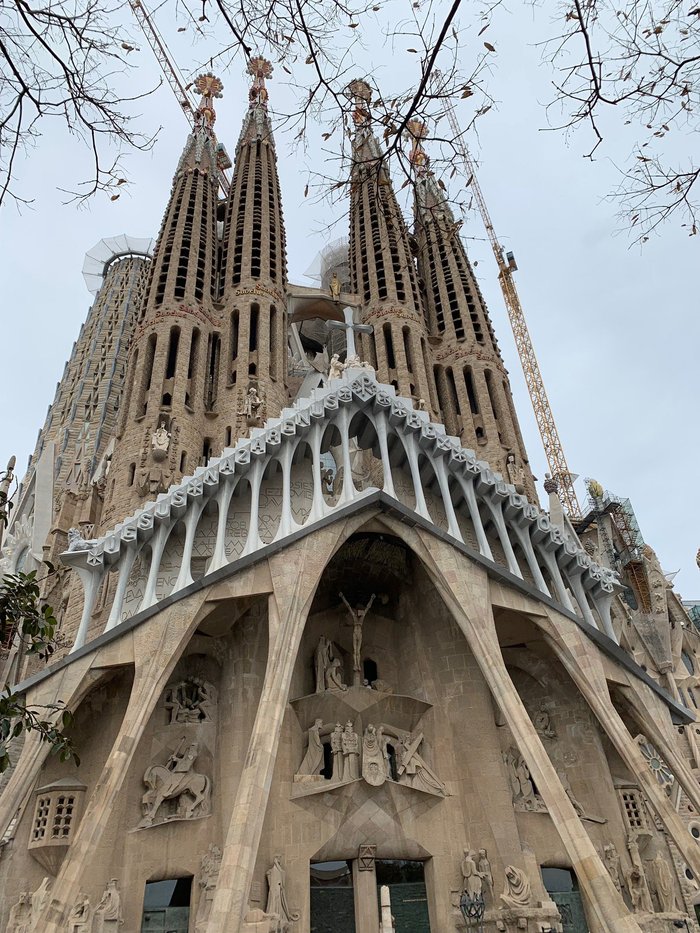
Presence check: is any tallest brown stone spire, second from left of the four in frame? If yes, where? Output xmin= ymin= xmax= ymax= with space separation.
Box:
xmin=219 ymin=56 xmax=287 ymax=438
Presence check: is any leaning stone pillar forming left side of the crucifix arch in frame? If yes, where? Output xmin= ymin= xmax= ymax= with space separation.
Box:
xmin=206 ymin=530 xmax=337 ymax=933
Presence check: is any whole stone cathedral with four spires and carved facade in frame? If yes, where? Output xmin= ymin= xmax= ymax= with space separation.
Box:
xmin=0 ymin=58 xmax=700 ymax=933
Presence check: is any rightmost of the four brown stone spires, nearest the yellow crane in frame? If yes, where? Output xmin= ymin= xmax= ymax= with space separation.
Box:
xmin=411 ymin=125 xmax=537 ymax=501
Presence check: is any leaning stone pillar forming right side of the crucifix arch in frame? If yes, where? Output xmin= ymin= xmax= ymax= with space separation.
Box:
xmin=410 ymin=534 xmax=644 ymax=933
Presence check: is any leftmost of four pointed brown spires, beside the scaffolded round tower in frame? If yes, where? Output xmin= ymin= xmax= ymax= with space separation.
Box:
xmin=104 ymin=73 xmax=223 ymax=522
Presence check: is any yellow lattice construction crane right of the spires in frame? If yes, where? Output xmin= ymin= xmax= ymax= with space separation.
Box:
xmin=434 ymin=86 xmax=581 ymax=521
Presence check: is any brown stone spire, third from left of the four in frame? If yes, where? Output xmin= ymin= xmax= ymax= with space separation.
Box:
xmin=348 ymin=81 xmax=436 ymax=411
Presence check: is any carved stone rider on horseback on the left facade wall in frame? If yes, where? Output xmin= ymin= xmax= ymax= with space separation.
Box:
xmin=139 ymin=737 xmax=211 ymax=827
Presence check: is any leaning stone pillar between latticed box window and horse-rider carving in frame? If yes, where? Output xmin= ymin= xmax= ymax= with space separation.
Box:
xmin=36 ymin=594 xmax=208 ymax=933
